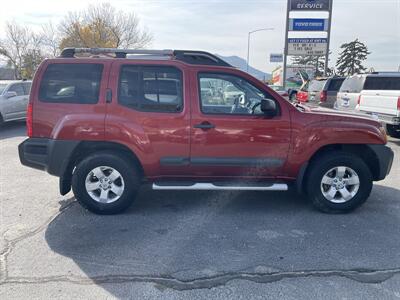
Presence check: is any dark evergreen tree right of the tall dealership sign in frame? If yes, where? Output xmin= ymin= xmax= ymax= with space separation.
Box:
xmin=336 ymin=39 xmax=371 ymax=76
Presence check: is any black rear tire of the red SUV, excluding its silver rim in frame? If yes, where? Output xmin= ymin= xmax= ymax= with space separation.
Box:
xmin=72 ymin=151 xmax=140 ymax=215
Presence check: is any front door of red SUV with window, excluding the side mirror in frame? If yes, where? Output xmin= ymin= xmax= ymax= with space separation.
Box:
xmin=190 ymin=72 xmax=291 ymax=178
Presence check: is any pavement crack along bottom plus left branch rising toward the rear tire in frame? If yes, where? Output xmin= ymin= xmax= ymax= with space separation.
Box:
xmin=0 ymin=198 xmax=400 ymax=291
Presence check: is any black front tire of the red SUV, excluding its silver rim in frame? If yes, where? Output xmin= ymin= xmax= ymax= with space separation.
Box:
xmin=307 ymin=151 xmax=373 ymax=214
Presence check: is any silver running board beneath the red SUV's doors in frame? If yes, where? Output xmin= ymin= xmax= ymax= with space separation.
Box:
xmin=153 ymin=182 xmax=288 ymax=191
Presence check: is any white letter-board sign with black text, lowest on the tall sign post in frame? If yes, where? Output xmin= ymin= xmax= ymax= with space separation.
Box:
xmin=287 ymin=38 xmax=328 ymax=56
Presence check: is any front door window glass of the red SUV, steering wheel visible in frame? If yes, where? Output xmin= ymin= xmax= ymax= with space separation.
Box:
xmin=198 ymin=73 xmax=270 ymax=115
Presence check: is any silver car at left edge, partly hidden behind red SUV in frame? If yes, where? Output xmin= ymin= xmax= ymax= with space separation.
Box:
xmin=0 ymin=80 xmax=32 ymax=125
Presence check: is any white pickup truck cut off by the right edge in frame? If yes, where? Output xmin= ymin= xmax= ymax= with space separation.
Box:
xmin=357 ymin=72 xmax=400 ymax=138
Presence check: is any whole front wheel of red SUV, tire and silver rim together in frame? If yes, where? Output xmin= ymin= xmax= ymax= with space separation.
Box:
xmin=307 ymin=151 xmax=373 ymax=214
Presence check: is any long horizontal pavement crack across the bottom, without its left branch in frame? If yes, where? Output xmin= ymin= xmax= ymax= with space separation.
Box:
xmin=0 ymin=268 xmax=400 ymax=291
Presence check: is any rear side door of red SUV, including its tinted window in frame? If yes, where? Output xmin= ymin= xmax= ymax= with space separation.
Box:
xmin=105 ymin=59 xmax=190 ymax=179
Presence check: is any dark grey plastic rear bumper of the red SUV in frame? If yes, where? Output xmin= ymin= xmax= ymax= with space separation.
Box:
xmin=18 ymin=138 xmax=79 ymax=177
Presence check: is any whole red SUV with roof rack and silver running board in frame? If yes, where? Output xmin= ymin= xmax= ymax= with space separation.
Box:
xmin=19 ymin=48 xmax=393 ymax=214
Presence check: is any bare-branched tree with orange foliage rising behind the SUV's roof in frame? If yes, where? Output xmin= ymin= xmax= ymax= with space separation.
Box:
xmin=59 ymin=4 xmax=153 ymax=49
